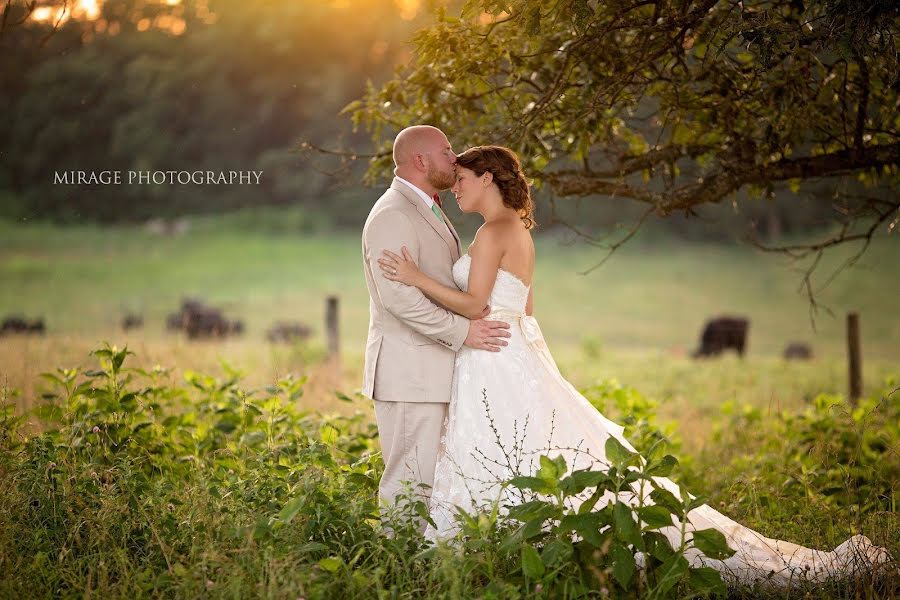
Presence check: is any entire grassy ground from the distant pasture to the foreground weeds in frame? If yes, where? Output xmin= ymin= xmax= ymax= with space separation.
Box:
xmin=0 ymin=217 xmax=900 ymax=599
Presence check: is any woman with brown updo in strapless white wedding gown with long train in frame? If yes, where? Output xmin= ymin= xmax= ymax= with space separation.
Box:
xmin=379 ymin=146 xmax=889 ymax=584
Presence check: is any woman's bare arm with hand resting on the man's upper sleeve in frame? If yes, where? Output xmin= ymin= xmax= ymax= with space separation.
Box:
xmin=378 ymin=227 xmax=503 ymax=319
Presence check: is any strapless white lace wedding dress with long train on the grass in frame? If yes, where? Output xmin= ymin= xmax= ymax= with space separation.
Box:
xmin=425 ymin=254 xmax=890 ymax=584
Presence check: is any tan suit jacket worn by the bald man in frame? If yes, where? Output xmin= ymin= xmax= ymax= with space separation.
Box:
xmin=362 ymin=179 xmax=469 ymax=402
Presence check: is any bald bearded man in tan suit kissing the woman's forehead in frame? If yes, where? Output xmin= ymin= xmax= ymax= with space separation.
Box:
xmin=362 ymin=125 xmax=510 ymax=520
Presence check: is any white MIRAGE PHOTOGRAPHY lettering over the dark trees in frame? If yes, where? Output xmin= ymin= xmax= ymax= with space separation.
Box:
xmin=53 ymin=171 xmax=263 ymax=185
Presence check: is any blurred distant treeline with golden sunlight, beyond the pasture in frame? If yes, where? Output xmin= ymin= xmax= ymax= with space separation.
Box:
xmin=0 ymin=0 xmax=852 ymax=237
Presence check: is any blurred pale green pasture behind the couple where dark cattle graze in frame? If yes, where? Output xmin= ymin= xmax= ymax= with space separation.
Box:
xmin=0 ymin=218 xmax=900 ymax=448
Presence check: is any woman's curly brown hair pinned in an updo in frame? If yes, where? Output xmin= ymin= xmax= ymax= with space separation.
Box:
xmin=456 ymin=146 xmax=537 ymax=229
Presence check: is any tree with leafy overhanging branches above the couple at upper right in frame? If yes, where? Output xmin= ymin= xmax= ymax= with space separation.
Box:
xmin=348 ymin=0 xmax=900 ymax=274
